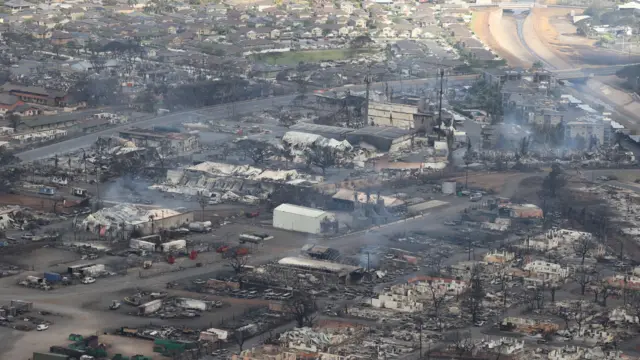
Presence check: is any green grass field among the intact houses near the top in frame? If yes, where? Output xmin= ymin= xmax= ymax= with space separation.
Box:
xmin=251 ymin=49 xmax=377 ymax=65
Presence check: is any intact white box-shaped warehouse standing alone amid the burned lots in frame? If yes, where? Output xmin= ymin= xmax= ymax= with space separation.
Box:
xmin=273 ymin=204 xmax=335 ymax=234
